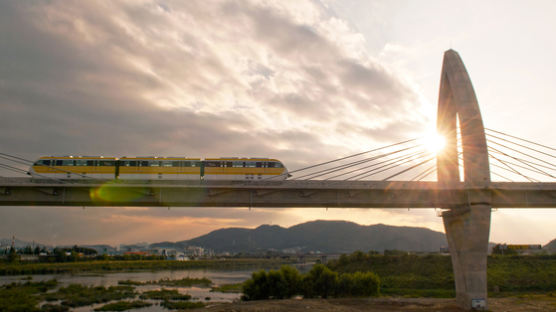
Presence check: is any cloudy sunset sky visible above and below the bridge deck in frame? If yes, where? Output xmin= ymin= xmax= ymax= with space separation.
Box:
xmin=0 ymin=0 xmax=556 ymax=245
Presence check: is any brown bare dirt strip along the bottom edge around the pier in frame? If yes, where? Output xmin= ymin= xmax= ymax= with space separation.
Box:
xmin=199 ymin=297 xmax=556 ymax=312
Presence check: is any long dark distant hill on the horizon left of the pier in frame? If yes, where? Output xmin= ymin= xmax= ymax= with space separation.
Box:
xmin=151 ymin=221 xmax=448 ymax=253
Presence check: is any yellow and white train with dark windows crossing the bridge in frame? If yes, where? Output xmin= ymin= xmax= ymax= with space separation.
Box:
xmin=29 ymin=156 xmax=288 ymax=181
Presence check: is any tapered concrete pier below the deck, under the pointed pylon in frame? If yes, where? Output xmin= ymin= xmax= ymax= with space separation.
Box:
xmin=442 ymin=204 xmax=491 ymax=310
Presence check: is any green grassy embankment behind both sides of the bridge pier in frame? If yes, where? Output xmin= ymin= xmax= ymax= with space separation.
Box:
xmin=328 ymin=252 xmax=556 ymax=298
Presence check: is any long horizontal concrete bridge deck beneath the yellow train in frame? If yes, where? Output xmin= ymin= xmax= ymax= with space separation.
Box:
xmin=0 ymin=178 xmax=556 ymax=208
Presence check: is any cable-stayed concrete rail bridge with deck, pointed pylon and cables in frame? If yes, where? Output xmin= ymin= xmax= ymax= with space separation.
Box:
xmin=0 ymin=50 xmax=556 ymax=309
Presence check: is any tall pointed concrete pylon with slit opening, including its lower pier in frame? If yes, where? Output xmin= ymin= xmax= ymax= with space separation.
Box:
xmin=437 ymin=50 xmax=491 ymax=310
